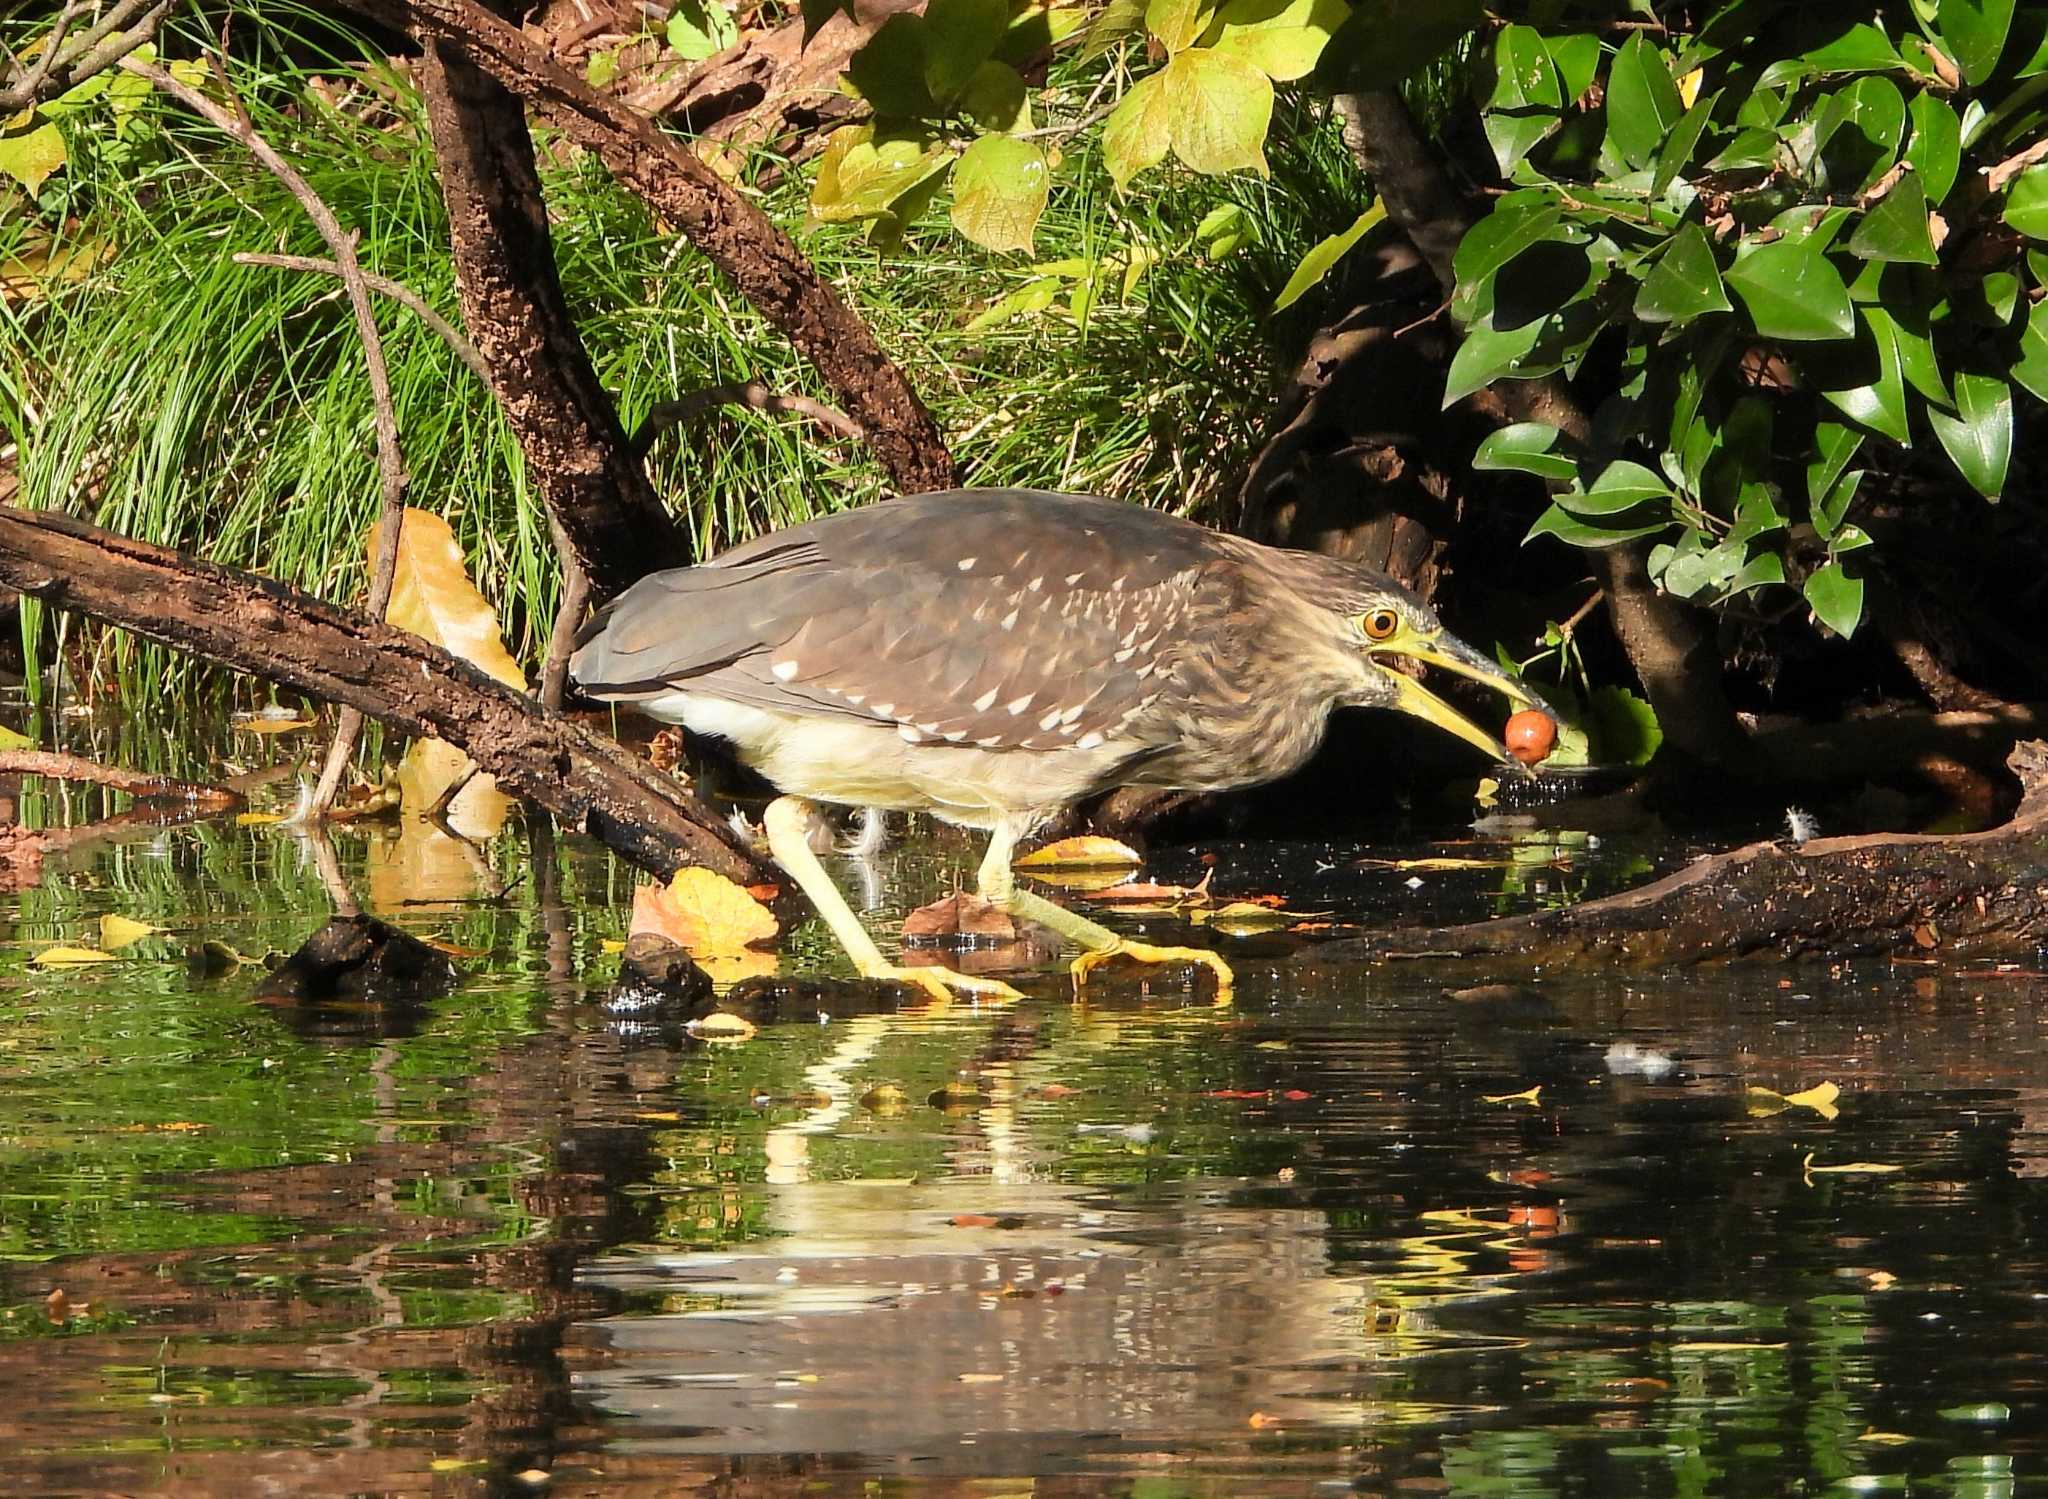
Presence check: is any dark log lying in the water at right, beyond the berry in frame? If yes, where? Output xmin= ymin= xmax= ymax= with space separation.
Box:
xmin=1317 ymin=739 xmax=2048 ymax=969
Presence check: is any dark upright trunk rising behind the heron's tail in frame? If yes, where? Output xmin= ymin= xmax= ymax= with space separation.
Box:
xmin=422 ymin=43 xmax=690 ymax=596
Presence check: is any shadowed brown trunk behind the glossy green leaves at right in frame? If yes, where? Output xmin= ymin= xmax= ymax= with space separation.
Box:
xmin=1337 ymin=92 xmax=1747 ymax=768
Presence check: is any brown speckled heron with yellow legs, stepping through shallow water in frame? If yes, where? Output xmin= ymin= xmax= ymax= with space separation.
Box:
xmin=569 ymin=489 xmax=1546 ymax=997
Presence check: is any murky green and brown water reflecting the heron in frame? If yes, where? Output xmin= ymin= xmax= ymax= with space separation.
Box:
xmin=0 ymin=774 xmax=2048 ymax=1499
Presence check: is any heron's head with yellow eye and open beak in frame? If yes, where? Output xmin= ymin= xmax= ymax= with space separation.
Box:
xmin=1280 ymin=553 xmax=1556 ymax=768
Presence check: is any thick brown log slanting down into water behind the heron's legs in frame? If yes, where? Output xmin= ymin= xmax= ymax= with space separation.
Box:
xmin=0 ymin=508 xmax=768 ymax=881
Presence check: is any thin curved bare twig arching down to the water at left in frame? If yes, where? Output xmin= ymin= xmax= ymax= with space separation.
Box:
xmin=121 ymin=57 xmax=406 ymax=821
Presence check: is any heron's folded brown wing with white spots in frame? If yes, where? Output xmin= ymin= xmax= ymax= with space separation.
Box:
xmin=573 ymin=489 xmax=1231 ymax=750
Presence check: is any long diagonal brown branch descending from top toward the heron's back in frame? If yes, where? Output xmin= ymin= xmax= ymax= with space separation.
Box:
xmin=346 ymin=0 xmax=958 ymax=494
